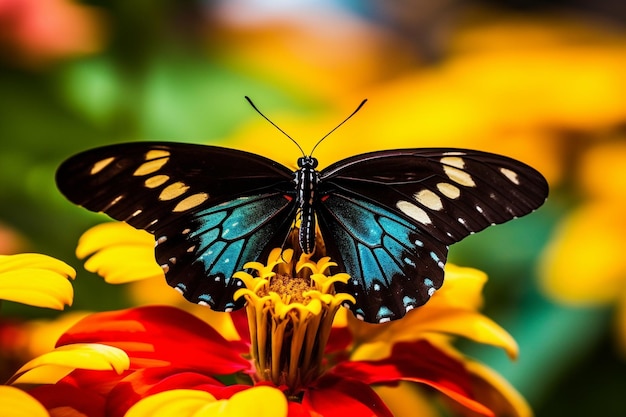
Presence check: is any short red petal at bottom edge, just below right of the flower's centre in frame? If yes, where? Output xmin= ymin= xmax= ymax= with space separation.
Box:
xmin=302 ymin=374 xmax=393 ymax=417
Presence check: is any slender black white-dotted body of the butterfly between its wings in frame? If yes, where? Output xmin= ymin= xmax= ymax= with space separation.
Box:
xmin=294 ymin=156 xmax=319 ymax=254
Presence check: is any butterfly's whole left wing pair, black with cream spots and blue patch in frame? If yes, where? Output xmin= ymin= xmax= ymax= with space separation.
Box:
xmin=57 ymin=142 xmax=295 ymax=310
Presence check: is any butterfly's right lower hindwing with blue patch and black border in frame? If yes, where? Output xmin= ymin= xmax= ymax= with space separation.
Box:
xmin=318 ymin=194 xmax=448 ymax=323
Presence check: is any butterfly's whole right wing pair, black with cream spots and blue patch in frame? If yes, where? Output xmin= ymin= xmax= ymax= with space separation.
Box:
xmin=318 ymin=148 xmax=548 ymax=322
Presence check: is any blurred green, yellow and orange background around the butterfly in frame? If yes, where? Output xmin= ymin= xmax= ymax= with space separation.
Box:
xmin=0 ymin=0 xmax=626 ymax=416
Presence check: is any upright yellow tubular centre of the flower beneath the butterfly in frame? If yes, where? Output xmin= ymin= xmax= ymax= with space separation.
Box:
xmin=234 ymin=249 xmax=354 ymax=395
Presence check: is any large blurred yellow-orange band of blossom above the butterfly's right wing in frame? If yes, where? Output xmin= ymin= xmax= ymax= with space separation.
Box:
xmin=228 ymin=16 xmax=626 ymax=193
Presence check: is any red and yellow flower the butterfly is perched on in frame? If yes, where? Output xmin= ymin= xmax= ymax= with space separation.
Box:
xmin=9 ymin=242 xmax=530 ymax=417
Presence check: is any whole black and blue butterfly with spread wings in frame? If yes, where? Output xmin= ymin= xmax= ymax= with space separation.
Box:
xmin=56 ymin=105 xmax=548 ymax=323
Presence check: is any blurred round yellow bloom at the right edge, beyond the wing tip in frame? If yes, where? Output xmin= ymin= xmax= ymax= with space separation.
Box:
xmin=540 ymin=141 xmax=626 ymax=352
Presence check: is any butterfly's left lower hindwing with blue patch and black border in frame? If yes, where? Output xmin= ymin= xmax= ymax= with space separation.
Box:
xmin=155 ymin=193 xmax=294 ymax=311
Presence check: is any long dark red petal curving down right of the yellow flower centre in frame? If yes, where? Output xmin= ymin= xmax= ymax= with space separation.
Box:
xmin=330 ymin=340 xmax=493 ymax=416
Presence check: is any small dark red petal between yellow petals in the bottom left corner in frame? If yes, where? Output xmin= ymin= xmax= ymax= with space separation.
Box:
xmin=28 ymin=383 xmax=106 ymax=417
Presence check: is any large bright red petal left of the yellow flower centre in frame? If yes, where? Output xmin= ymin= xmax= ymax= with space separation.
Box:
xmin=57 ymin=306 xmax=250 ymax=374
